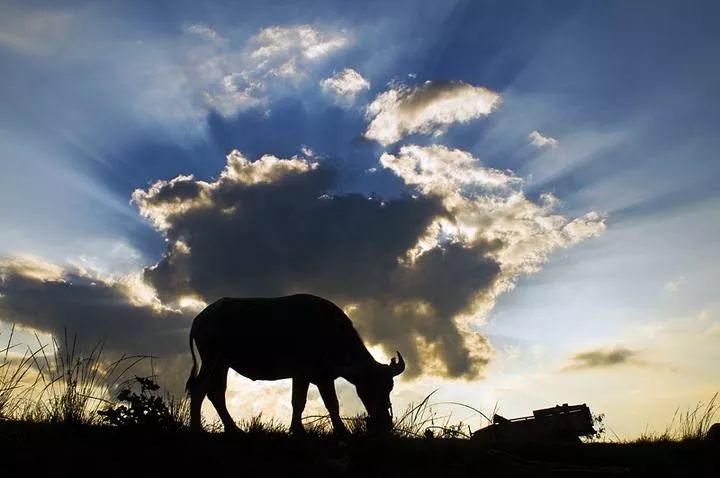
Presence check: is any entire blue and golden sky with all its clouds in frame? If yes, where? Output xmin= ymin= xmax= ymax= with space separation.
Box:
xmin=0 ymin=0 xmax=720 ymax=437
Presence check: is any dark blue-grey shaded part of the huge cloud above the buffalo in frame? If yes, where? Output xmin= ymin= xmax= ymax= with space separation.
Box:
xmin=141 ymin=155 xmax=499 ymax=376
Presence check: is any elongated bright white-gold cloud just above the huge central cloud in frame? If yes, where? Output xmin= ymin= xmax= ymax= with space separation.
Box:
xmin=365 ymin=81 xmax=501 ymax=146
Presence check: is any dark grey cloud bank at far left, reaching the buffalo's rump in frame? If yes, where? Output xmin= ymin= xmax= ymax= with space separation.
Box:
xmin=0 ymin=261 xmax=193 ymax=395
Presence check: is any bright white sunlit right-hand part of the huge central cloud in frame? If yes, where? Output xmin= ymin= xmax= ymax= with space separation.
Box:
xmin=380 ymin=145 xmax=605 ymax=282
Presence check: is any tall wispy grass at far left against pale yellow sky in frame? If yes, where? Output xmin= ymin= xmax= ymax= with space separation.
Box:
xmin=0 ymin=326 xmax=189 ymax=428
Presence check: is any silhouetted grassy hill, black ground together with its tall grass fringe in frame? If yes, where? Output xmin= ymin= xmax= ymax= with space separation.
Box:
xmin=0 ymin=332 xmax=720 ymax=478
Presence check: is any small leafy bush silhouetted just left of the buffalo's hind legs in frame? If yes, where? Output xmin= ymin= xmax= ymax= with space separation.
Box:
xmin=98 ymin=376 xmax=187 ymax=429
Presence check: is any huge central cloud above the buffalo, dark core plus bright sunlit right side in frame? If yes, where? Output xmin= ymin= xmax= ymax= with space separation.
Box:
xmin=126 ymin=145 xmax=604 ymax=377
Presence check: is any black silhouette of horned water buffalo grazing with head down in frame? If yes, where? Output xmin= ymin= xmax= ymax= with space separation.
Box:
xmin=186 ymin=294 xmax=405 ymax=434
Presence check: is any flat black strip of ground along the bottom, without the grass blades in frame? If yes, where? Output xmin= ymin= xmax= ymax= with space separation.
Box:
xmin=0 ymin=421 xmax=720 ymax=478
